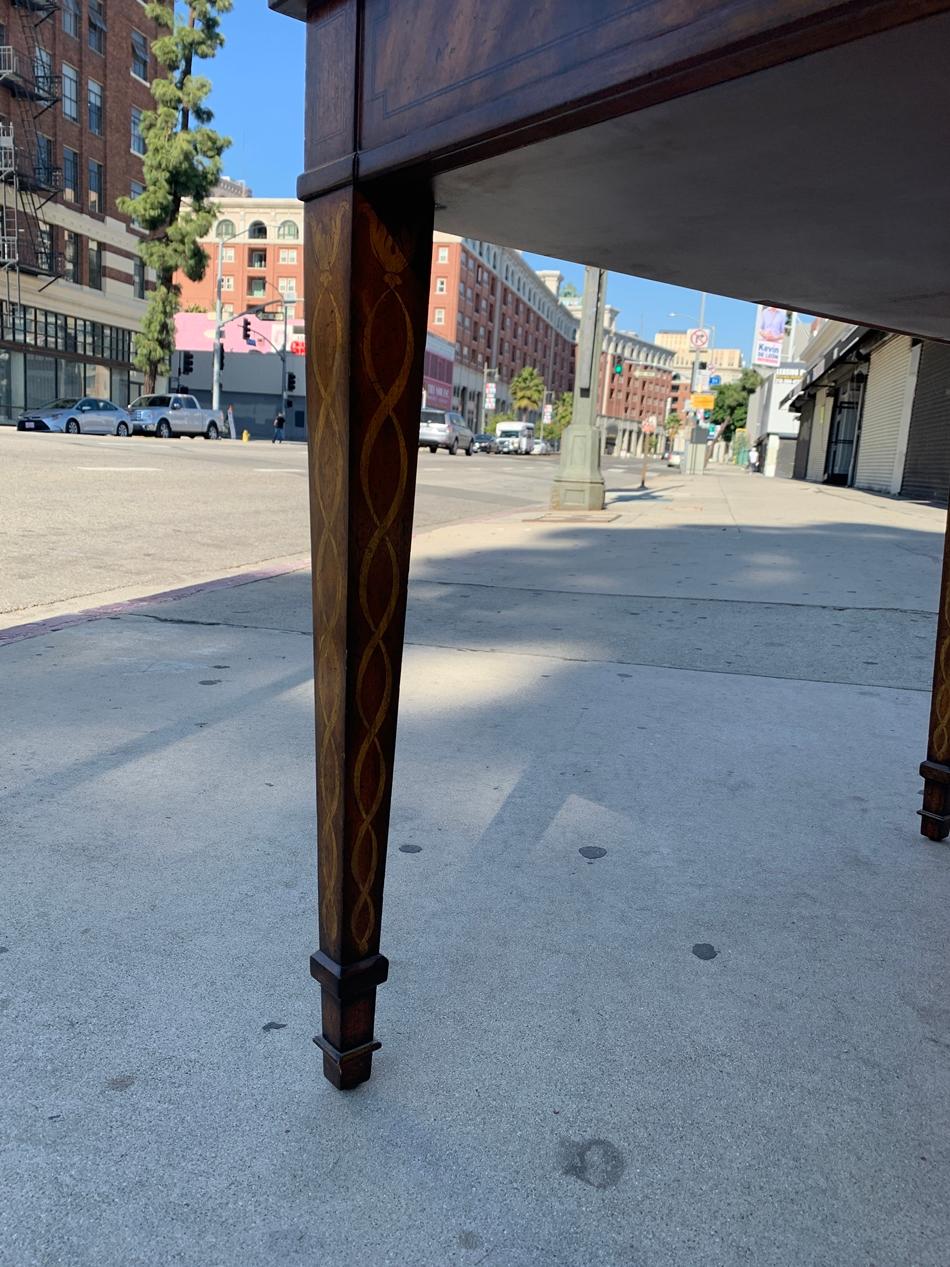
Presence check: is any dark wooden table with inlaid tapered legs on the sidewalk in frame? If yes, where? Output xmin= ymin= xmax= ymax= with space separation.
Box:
xmin=271 ymin=0 xmax=950 ymax=1088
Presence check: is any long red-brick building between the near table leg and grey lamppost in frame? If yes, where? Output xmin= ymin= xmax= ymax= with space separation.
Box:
xmin=428 ymin=232 xmax=578 ymax=430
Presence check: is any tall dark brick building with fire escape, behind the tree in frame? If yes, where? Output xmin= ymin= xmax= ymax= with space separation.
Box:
xmin=0 ymin=0 xmax=157 ymax=421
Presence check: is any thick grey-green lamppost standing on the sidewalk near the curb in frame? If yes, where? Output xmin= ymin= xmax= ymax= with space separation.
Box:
xmin=551 ymin=266 xmax=607 ymax=511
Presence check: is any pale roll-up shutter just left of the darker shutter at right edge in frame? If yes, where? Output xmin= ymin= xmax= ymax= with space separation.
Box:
xmin=854 ymin=334 xmax=911 ymax=493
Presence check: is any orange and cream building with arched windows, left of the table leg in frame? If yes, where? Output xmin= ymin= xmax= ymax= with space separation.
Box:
xmin=176 ymin=193 xmax=304 ymax=337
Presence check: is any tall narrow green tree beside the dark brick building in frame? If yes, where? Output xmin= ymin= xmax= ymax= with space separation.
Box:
xmin=117 ymin=0 xmax=232 ymax=393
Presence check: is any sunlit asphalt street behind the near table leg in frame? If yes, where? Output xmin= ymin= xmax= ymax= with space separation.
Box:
xmin=0 ymin=430 xmax=556 ymax=627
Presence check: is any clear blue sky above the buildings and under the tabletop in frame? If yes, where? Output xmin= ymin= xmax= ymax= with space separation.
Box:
xmin=208 ymin=0 xmax=755 ymax=356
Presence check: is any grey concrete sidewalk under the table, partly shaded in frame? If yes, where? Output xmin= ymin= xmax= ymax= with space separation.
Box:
xmin=0 ymin=468 xmax=950 ymax=1267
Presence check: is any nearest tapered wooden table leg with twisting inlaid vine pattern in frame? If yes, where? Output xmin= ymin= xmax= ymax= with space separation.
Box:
xmin=305 ymin=180 xmax=433 ymax=1090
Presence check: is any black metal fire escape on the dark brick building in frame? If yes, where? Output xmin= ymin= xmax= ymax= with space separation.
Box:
xmin=0 ymin=0 xmax=63 ymax=304
